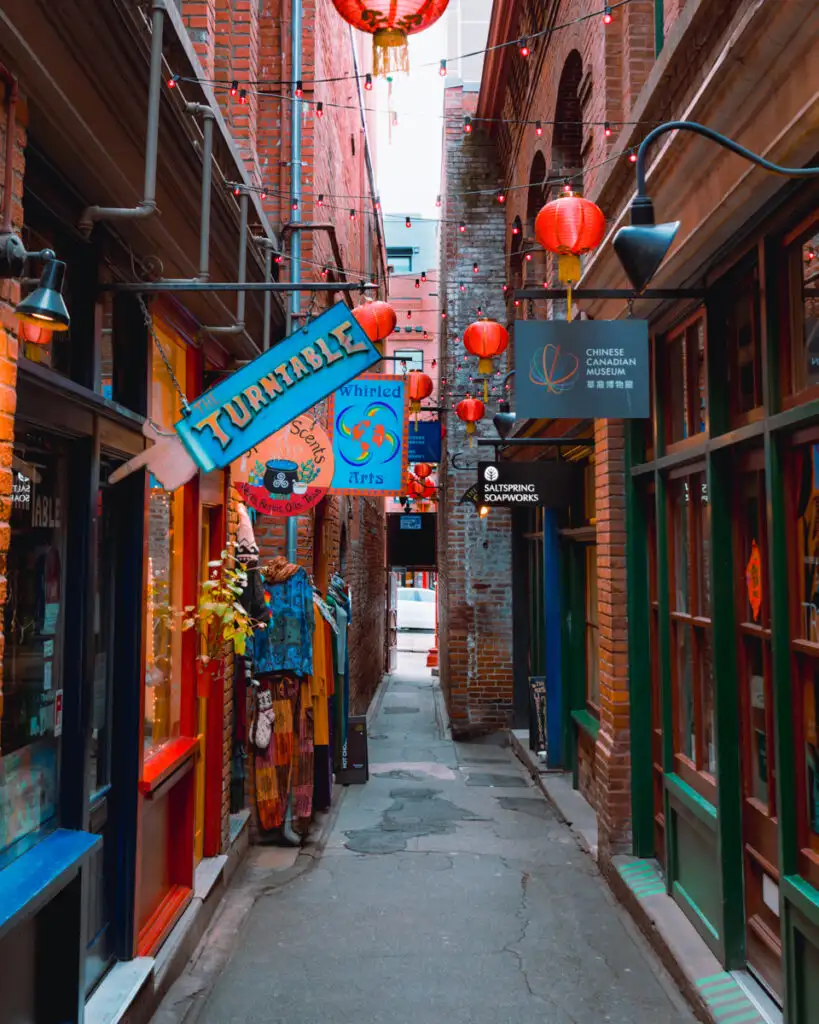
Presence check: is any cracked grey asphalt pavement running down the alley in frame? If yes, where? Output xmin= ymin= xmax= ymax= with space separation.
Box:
xmin=197 ymin=654 xmax=694 ymax=1024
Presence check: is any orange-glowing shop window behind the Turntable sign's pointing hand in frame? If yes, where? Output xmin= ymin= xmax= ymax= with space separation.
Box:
xmin=143 ymin=324 xmax=185 ymax=751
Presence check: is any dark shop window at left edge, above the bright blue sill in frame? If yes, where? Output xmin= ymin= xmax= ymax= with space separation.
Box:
xmin=0 ymin=433 xmax=67 ymax=858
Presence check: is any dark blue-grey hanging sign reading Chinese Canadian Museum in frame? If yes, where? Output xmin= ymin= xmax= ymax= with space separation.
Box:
xmin=515 ymin=319 xmax=649 ymax=420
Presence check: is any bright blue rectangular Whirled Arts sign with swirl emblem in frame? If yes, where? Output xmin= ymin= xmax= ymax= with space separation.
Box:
xmin=332 ymin=374 xmax=408 ymax=498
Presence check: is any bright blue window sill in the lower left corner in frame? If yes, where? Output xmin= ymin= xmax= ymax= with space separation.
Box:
xmin=0 ymin=828 xmax=102 ymax=939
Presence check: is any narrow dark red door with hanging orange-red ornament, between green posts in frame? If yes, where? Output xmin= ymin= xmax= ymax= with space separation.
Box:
xmin=733 ymin=451 xmax=782 ymax=996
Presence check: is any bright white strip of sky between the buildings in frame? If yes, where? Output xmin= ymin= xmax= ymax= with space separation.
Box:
xmin=376 ymin=17 xmax=446 ymax=219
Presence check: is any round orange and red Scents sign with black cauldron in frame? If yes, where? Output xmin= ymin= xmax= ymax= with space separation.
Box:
xmin=230 ymin=413 xmax=335 ymax=516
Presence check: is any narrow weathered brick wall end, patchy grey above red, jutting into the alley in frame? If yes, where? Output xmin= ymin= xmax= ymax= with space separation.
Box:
xmin=438 ymin=88 xmax=512 ymax=735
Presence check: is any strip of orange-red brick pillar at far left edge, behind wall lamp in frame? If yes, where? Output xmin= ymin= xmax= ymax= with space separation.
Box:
xmin=0 ymin=83 xmax=28 ymax=729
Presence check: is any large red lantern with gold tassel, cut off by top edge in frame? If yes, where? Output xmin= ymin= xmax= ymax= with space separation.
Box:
xmin=333 ymin=0 xmax=449 ymax=77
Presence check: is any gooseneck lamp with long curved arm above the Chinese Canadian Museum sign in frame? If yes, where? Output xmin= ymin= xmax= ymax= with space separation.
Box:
xmin=613 ymin=121 xmax=819 ymax=292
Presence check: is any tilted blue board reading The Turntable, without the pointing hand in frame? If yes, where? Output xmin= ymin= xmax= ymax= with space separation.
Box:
xmin=176 ymin=302 xmax=380 ymax=473
